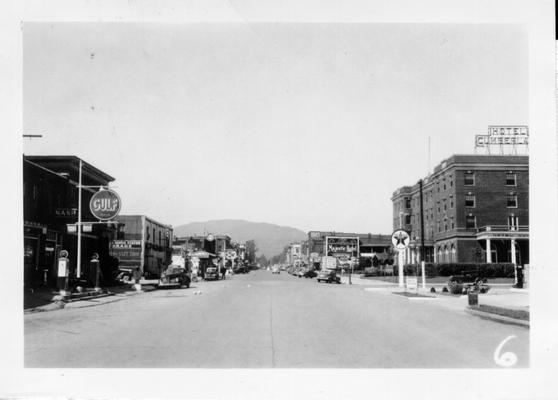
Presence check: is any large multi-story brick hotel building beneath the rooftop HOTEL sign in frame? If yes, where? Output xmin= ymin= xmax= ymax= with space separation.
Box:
xmin=391 ymin=155 xmax=529 ymax=265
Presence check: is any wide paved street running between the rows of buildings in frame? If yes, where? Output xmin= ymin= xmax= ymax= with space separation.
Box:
xmin=24 ymin=271 xmax=529 ymax=368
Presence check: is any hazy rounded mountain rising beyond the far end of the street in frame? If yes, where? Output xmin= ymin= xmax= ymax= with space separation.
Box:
xmin=174 ymin=219 xmax=307 ymax=258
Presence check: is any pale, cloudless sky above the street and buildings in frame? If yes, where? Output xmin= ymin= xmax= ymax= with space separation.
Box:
xmin=23 ymin=23 xmax=529 ymax=234
